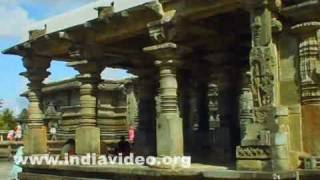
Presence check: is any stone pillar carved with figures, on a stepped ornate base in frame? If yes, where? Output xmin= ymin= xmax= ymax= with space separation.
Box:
xmin=236 ymin=0 xmax=288 ymax=170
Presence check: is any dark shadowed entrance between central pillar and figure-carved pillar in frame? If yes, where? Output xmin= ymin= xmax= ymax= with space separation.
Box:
xmin=172 ymin=11 xmax=251 ymax=167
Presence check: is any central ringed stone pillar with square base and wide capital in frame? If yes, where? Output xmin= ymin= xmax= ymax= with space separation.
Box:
xmin=144 ymin=43 xmax=183 ymax=156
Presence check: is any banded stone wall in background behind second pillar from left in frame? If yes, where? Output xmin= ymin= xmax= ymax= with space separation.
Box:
xmin=42 ymin=79 xmax=137 ymax=141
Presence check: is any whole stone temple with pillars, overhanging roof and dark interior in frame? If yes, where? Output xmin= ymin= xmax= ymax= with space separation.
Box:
xmin=4 ymin=0 xmax=320 ymax=180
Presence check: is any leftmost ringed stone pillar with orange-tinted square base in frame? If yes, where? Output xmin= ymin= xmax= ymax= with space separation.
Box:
xmin=21 ymin=56 xmax=50 ymax=154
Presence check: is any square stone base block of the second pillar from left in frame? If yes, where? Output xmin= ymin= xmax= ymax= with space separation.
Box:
xmin=75 ymin=127 xmax=100 ymax=155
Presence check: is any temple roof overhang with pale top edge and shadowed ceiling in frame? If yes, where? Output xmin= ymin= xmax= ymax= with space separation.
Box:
xmin=3 ymin=0 xmax=320 ymax=69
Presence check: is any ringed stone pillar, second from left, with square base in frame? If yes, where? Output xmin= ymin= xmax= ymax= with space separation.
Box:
xmin=68 ymin=60 xmax=103 ymax=154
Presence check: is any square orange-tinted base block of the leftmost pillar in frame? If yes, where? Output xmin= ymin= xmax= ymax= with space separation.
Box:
xmin=23 ymin=126 xmax=48 ymax=155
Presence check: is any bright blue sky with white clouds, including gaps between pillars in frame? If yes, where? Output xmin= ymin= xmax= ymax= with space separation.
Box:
xmin=0 ymin=0 xmax=132 ymax=113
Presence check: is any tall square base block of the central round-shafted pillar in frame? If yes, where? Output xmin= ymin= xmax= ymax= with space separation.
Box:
xmin=157 ymin=114 xmax=183 ymax=156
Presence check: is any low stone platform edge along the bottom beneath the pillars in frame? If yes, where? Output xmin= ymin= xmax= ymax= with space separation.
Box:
xmin=19 ymin=164 xmax=320 ymax=180
